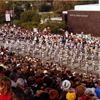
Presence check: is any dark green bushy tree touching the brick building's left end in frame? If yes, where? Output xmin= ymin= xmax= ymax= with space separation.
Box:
xmin=38 ymin=21 xmax=67 ymax=34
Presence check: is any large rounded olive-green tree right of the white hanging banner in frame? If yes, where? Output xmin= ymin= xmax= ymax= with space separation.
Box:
xmin=19 ymin=10 xmax=40 ymax=29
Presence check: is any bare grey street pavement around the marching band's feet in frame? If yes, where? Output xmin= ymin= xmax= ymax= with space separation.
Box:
xmin=0 ymin=37 xmax=99 ymax=74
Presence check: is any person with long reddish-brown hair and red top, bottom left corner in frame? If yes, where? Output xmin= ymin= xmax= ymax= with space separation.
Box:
xmin=0 ymin=76 xmax=13 ymax=100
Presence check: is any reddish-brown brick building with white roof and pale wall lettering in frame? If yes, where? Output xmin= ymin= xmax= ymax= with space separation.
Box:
xmin=62 ymin=0 xmax=100 ymax=37
